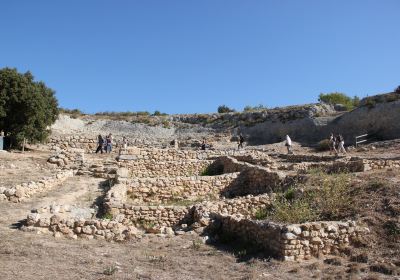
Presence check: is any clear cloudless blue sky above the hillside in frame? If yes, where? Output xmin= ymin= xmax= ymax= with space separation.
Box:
xmin=0 ymin=0 xmax=400 ymax=113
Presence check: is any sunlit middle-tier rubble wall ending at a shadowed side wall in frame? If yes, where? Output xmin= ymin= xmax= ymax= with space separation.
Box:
xmin=127 ymin=173 xmax=238 ymax=204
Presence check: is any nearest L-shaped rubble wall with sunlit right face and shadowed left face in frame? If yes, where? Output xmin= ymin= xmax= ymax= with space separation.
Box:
xmin=213 ymin=214 xmax=369 ymax=261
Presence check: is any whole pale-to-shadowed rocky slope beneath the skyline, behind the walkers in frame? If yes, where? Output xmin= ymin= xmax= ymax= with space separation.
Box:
xmin=52 ymin=93 xmax=400 ymax=147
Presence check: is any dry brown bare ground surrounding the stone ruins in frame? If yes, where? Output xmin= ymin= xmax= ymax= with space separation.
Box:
xmin=0 ymin=143 xmax=400 ymax=279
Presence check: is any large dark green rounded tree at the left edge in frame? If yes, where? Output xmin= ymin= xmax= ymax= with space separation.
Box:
xmin=0 ymin=68 xmax=58 ymax=148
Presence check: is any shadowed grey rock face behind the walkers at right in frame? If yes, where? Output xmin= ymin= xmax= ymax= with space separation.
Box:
xmin=240 ymin=100 xmax=400 ymax=144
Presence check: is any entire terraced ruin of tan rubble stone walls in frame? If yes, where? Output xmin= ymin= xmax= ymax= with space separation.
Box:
xmin=12 ymin=141 xmax=400 ymax=260
